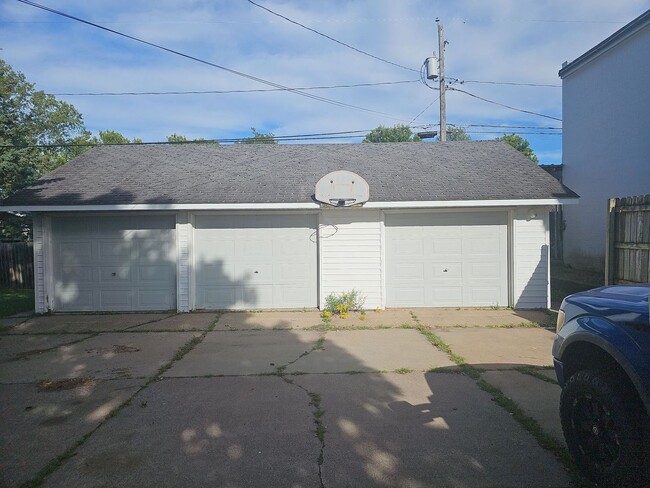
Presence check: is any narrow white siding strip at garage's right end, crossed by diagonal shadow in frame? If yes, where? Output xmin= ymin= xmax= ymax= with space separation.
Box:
xmin=512 ymin=207 xmax=550 ymax=309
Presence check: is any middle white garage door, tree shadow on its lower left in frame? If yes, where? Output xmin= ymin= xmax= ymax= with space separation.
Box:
xmin=194 ymin=215 xmax=317 ymax=309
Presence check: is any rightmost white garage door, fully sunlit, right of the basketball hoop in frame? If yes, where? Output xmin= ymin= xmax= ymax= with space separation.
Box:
xmin=386 ymin=212 xmax=508 ymax=307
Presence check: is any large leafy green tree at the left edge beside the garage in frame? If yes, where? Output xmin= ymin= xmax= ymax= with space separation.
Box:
xmin=0 ymin=59 xmax=92 ymax=239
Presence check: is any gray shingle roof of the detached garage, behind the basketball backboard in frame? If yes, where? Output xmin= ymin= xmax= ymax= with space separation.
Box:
xmin=2 ymin=141 xmax=576 ymax=206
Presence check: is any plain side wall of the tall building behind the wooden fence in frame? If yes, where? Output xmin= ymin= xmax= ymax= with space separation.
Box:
xmin=562 ymin=25 xmax=650 ymax=270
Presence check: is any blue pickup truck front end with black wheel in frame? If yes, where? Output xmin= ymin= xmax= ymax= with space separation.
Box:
xmin=553 ymin=284 xmax=650 ymax=487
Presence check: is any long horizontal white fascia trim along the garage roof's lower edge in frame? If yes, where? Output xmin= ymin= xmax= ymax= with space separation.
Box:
xmin=0 ymin=198 xmax=578 ymax=212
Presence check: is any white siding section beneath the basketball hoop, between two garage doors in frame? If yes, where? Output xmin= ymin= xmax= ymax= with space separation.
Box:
xmin=319 ymin=209 xmax=383 ymax=308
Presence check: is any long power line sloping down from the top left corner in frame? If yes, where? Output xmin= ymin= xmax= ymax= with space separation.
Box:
xmin=17 ymin=0 xmax=405 ymax=122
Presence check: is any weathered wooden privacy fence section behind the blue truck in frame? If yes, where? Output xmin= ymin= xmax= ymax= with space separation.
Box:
xmin=605 ymin=195 xmax=650 ymax=284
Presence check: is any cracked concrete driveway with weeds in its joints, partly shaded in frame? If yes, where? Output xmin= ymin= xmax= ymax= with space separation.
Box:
xmin=0 ymin=309 xmax=570 ymax=488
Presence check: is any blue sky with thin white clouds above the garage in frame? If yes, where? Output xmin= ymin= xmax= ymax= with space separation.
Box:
xmin=0 ymin=0 xmax=650 ymax=164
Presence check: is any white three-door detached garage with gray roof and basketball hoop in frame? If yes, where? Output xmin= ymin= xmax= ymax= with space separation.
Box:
xmin=0 ymin=141 xmax=577 ymax=313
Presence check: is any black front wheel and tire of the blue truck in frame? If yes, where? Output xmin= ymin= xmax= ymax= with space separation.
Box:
xmin=560 ymin=370 xmax=649 ymax=487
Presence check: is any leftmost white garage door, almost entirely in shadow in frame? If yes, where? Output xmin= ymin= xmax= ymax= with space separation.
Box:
xmin=52 ymin=215 xmax=176 ymax=311
